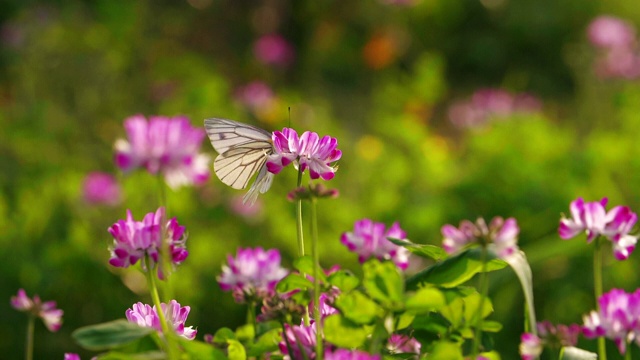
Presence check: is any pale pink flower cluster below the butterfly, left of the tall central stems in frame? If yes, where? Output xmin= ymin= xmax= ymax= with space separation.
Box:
xmin=218 ymin=247 xmax=288 ymax=303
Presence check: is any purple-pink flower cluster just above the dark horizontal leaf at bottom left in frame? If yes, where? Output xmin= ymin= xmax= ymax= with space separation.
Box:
xmin=125 ymin=300 xmax=198 ymax=340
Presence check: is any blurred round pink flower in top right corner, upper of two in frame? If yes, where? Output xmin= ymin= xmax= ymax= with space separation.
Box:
xmin=587 ymin=15 xmax=636 ymax=49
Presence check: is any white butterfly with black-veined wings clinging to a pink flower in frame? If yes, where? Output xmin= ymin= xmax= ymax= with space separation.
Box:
xmin=204 ymin=118 xmax=274 ymax=204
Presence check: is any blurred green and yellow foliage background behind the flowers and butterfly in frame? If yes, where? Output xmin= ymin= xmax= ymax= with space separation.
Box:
xmin=0 ymin=0 xmax=640 ymax=359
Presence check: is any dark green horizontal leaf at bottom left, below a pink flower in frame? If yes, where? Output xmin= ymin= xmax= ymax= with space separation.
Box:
xmin=71 ymin=319 xmax=155 ymax=350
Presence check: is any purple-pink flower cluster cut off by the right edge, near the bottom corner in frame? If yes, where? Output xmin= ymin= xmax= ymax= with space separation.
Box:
xmin=582 ymin=289 xmax=640 ymax=354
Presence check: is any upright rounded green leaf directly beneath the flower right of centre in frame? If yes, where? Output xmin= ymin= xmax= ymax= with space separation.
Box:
xmin=362 ymin=259 xmax=404 ymax=310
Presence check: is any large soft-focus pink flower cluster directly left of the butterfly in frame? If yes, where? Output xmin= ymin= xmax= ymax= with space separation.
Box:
xmin=115 ymin=115 xmax=209 ymax=188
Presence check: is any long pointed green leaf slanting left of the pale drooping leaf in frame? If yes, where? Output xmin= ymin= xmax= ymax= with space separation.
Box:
xmin=407 ymin=248 xmax=507 ymax=290
